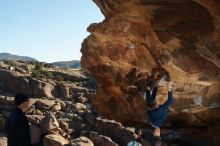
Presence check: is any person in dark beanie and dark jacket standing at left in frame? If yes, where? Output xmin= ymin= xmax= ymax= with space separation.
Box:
xmin=6 ymin=93 xmax=32 ymax=146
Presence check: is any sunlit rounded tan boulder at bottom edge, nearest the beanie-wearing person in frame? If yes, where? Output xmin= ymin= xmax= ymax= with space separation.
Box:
xmin=43 ymin=134 xmax=68 ymax=146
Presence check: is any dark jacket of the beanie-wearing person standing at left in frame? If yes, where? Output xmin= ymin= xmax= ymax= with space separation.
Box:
xmin=7 ymin=108 xmax=32 ymax=146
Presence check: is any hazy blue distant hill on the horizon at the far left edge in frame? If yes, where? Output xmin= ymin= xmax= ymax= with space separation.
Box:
xmin=0 ymin=53 xmax=38 ymax=61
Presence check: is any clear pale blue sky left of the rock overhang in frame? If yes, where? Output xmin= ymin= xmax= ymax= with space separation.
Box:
xmin=0 ymin=0 xmax=104 ymax=62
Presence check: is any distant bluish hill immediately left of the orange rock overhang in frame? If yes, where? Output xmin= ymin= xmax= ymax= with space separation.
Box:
xmin=52 ymin=60 xmax=81 ymax=68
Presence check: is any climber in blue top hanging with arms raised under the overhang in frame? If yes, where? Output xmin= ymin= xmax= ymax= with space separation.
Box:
xmin=146 ymin=75 xmax=173 ymax=137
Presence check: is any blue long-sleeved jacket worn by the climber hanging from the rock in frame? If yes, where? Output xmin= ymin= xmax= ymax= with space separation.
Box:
xmin=146 ymin=87 xmax=173 ymax=127
